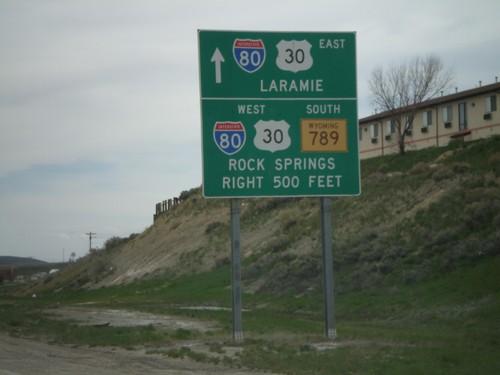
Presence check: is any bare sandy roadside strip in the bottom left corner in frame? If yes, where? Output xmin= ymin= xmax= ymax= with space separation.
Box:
xmin=0 ymin=333 xmax=278 ymax=375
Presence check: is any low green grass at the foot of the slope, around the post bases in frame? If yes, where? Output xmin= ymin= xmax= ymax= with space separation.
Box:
xmin=0 ymin=256 xmax=500 ymax=374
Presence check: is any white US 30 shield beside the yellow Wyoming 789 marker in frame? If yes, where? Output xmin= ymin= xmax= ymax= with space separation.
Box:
xmin=253 ymin=120 xmax=292 ymax=152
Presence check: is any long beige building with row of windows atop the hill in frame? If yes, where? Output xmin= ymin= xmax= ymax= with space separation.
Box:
xmin=359 ymin=82 xmax=500 ymax=159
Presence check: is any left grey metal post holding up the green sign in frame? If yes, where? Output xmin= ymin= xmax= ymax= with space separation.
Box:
xmin=231 ymin=198 xmax=243 ymax=342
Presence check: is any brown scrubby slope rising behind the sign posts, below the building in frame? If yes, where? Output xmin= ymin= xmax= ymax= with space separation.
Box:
xmin=38 ymin=137 xmax=500 ymax=294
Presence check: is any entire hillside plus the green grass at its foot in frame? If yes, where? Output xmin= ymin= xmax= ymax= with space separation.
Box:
xmin=4 ymin=137 xmax=500 ymax=375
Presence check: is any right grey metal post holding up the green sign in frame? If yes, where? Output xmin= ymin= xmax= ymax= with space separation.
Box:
xmin=321 ymin=197 xmax=337 ymax=339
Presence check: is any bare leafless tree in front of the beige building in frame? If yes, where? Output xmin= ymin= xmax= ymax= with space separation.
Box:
xmin=368 ymin=55 xmax=453 ymax=155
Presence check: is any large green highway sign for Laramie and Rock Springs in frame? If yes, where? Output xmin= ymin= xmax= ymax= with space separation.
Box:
xmin=198 ymin=30 xmax=360 ymax=198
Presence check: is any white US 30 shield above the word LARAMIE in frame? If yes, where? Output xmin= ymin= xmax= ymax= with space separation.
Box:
xmin=276 ymin=39 xmax=313 ymax=73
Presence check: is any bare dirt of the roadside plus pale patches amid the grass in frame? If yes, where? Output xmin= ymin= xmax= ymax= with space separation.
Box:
xmin=0 ymin=306 xmax=278 ymax=375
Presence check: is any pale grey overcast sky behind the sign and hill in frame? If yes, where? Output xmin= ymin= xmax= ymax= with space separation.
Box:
xmin=0 ymin=0 xmax=500 ymax=261
